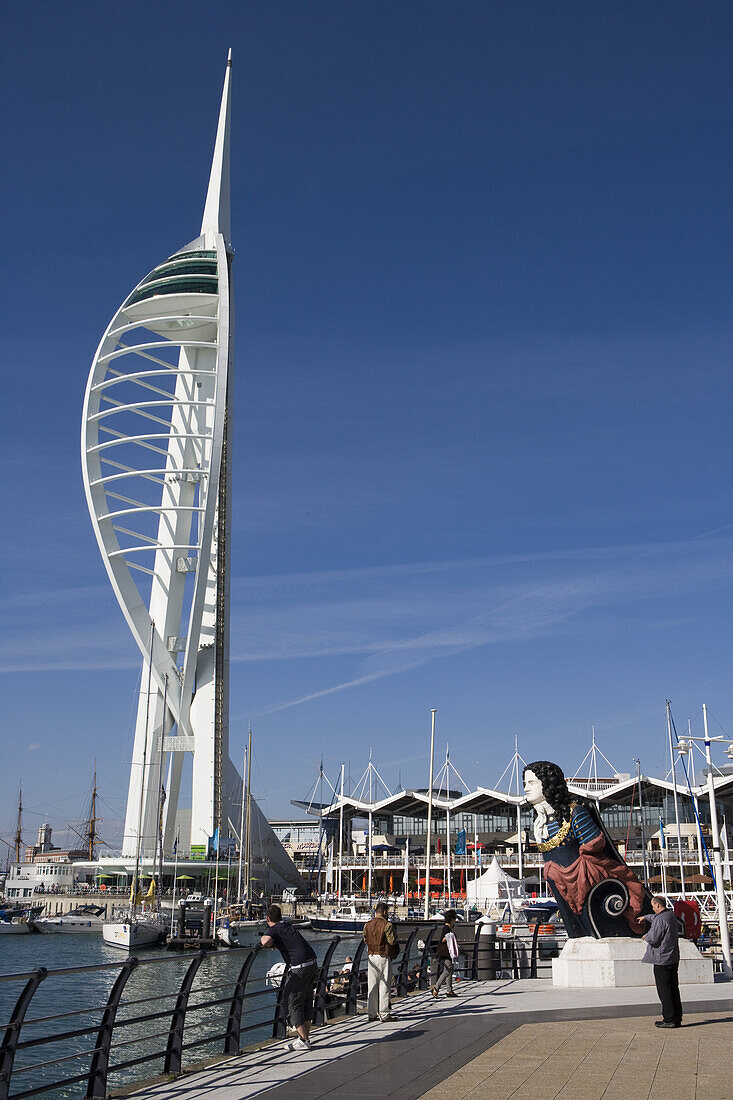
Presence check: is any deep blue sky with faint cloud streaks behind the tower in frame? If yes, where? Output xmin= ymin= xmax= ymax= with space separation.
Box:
xmin=0 ymin=0 xmax=733 ymax=842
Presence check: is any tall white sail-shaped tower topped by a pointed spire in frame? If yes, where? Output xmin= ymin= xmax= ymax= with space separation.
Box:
xmin=81 ymin=53 xmax=236 ymax=857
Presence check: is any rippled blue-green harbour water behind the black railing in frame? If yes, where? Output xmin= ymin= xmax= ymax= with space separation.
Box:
xmin=0 ymin=933 xmax=358 ymax=1100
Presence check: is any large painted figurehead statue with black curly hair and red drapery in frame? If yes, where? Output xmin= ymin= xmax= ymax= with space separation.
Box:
xmin=524 ymin=760 xmax=652 ymax=939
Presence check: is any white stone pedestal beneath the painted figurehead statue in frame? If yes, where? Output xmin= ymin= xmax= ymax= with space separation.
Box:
xmin=553 ymin=936 xmax=713 ymax=989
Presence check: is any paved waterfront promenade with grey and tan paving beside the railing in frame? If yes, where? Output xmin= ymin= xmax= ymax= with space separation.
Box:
xmin=125 ymin=979 xmax=733 ymax=1100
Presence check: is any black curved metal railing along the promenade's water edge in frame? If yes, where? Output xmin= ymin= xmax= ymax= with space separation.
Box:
xmin=0 ymin=924 xmax=565 ymax=1100
